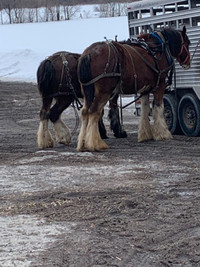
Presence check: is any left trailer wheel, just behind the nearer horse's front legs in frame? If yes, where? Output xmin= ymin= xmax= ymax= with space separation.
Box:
xmin=163 ymin=94 xmax=182 ymax=134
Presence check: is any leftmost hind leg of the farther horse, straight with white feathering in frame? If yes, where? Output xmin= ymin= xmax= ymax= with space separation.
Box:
xmin=37 ymin=98 xmax=54 ymax=148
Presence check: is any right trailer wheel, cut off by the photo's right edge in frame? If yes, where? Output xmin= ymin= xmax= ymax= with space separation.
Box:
xmin=178 ymin=94 xmax=200 ymax=136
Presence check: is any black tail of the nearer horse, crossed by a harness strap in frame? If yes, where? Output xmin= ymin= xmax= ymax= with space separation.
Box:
xmin=78 ymin=55 xmax=95 ymax=108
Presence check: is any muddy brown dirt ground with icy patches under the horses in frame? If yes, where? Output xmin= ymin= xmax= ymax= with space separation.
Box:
xmin=0 ymin=82 xmax=200 ymax=267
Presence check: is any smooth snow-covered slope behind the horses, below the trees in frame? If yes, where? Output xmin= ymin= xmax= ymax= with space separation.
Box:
xmin=0 ymin=9 xmax=129 ymax=83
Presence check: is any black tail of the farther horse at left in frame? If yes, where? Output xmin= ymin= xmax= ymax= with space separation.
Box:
xmin=37 ymin=59 xmax=55 ymax=97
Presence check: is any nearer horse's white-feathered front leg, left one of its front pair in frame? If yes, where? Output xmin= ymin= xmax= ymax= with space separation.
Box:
xmin=138 ymin=95 xmax=153 ymax=142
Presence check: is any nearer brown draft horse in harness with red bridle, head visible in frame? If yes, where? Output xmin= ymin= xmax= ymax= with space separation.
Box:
xmin=77 ymin=27 xmax=190 ymax=151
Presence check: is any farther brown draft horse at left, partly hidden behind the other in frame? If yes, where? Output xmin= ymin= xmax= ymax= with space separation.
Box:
xmin=37 ymin=51 xmax=126 ymax=148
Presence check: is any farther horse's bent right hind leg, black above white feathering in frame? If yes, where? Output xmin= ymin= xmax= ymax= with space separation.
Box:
xmin=49 ymin=96 xmax=71 ymax=145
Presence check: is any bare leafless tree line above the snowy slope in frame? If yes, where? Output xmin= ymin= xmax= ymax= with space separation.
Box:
xmin=0 ymin=0 xmax=130 ymax=24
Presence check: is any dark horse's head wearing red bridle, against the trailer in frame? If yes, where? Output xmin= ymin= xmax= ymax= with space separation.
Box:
xmin=164 ymin=26 xmax=191 ymax=69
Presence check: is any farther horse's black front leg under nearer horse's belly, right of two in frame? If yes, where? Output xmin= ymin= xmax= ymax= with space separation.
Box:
xmin=108 ymin=95 xmax=127 ymax=138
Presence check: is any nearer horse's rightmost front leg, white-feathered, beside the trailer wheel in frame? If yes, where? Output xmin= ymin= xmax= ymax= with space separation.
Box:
xmin=152 ymin=85 xmax=173 ymax=140
